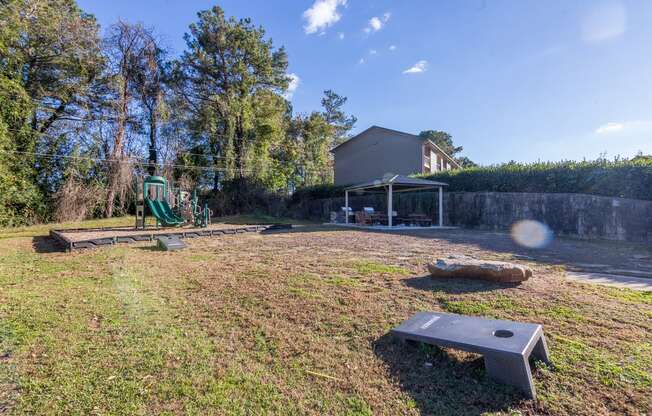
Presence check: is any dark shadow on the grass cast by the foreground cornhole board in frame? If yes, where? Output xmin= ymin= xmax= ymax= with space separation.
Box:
xmin=372 ymin=334 xmax=533 ymax=415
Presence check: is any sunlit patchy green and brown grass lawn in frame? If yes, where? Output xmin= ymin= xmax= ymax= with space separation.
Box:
xmin=0 ymin=218 xmax=652 ymax=415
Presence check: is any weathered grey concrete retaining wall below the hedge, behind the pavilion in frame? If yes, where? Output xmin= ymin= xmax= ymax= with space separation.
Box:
xmin=292 ymin=192 xmax=652 ymax=243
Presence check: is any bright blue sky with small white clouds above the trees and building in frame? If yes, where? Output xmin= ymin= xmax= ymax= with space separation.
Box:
xmin=78 ymin=0 xmax=652 ymax=164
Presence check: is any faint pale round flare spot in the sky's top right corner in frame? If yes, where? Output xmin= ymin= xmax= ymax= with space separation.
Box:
xmin=581 ymin=2 xmax=627 ymax=43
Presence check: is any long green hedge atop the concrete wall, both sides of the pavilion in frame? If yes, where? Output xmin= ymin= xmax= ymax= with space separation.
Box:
xmin=294 ymin=157 xmax=652 ymax=201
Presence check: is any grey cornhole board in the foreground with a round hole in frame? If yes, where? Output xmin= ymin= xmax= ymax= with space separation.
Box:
xmin=391 ymin=312 xmax=550 ymax=399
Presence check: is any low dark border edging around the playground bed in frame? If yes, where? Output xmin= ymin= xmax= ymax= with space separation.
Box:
xmin=50 ymin=224 xmax=292 ymax=252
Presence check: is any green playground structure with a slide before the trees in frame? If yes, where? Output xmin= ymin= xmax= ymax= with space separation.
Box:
xmin=136 ymin=176 xmax=212 ymax=230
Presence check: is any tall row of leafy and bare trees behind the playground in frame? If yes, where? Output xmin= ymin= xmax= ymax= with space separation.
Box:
xmin=0 ymin=0 xmax=356 ymax=225
